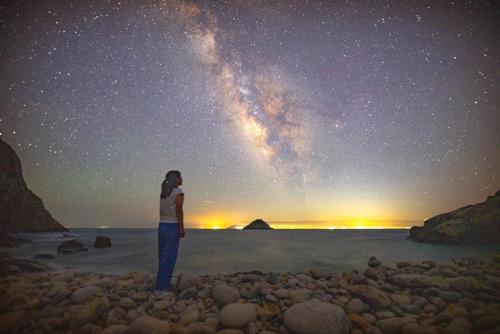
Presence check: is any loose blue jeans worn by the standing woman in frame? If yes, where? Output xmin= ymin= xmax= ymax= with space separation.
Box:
xmin=156 ymin=223 xmax=179 ymax=290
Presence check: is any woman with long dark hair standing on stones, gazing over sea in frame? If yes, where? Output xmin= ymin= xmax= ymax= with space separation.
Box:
xmin=156 ymin=170 xmax=185 ymax=290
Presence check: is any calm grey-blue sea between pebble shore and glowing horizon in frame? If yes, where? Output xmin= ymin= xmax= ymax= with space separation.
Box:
xmin=8 ymin=228 xmax=500 ymax=274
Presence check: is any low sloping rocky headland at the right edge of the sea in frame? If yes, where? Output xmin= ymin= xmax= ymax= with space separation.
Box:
xmin=410 ymin=191 xmax=500 ymax=244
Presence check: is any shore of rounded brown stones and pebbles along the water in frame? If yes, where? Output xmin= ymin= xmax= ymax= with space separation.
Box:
xmin=0 ymin=255 xmax=500 ymax=334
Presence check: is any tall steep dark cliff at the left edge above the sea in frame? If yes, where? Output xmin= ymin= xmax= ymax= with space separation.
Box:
xmin=0 ymin=138 xmax=67 ymax=232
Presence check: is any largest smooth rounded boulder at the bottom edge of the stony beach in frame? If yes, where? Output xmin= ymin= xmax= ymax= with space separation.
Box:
xmin=283 ymin=299 xmax=352 ymax=334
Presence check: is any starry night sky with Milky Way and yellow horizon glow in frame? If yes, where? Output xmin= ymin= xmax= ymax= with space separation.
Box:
xmin=0 ymin=0 xmax=500 ymax=228
